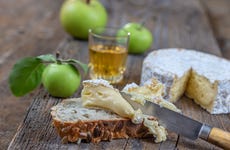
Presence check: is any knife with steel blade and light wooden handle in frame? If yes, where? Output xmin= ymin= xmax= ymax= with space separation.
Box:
xmin=120 ymin=92 xmax=230 ymax=150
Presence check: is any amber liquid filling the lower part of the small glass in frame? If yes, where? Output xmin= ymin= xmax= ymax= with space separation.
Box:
xmin=89 ymin=44 xmax=128 ymax=83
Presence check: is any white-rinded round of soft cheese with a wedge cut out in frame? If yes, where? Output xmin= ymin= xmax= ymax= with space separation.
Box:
xmin=141 ymin=48 xmax=230 ymax=114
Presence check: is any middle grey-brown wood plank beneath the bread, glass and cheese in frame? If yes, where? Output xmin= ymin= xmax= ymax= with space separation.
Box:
xmin=8 ymin=0 xmax=230 ymax=150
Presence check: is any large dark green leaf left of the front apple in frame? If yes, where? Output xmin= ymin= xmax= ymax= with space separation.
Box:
xmin=9 ymin=57 xmax=45 ymax=96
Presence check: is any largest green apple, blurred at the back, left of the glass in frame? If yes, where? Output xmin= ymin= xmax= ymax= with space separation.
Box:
xmin=60 ymin=0 xmax=107 ymax=40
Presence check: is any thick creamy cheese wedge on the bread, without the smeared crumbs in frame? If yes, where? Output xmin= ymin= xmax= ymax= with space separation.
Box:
xmin=81 ymin=79 xmax=134 ymax=118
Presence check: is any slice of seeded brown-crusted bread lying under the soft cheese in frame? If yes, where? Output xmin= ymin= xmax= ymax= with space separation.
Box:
xmin=51 ymin=98 xmax=167 ymax=143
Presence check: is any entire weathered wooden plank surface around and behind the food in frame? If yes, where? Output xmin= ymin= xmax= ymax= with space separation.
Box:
xmin=0 ymin=0 xmax=230 ymax=149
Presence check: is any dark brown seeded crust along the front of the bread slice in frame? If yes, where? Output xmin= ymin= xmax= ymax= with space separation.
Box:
xmin=51 ymin=99 xmax=156 ymax=143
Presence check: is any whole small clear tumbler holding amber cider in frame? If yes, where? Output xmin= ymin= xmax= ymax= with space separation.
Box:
xmin=89 ymin=27 xmax=129 ymax=83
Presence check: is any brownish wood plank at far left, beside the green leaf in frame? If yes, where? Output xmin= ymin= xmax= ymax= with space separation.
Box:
xmin=0 ymin=0 xmax=65 ymax=149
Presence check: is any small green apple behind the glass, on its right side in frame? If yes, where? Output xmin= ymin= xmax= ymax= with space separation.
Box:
xmin=122 ymin=23 xmax=153 ymax=54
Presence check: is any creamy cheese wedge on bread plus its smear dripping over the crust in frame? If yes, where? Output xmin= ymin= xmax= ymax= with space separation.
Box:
xmin=81 ymin=79 xmax=167 ymax=142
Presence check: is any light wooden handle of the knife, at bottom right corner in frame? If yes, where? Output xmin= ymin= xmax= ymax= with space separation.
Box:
xmin=208 ymin=127 xmax=230 ymax=150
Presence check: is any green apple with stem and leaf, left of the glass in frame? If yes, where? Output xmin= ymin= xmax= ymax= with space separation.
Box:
xmin=42 ymin=63 xmax=81 ymax=97
